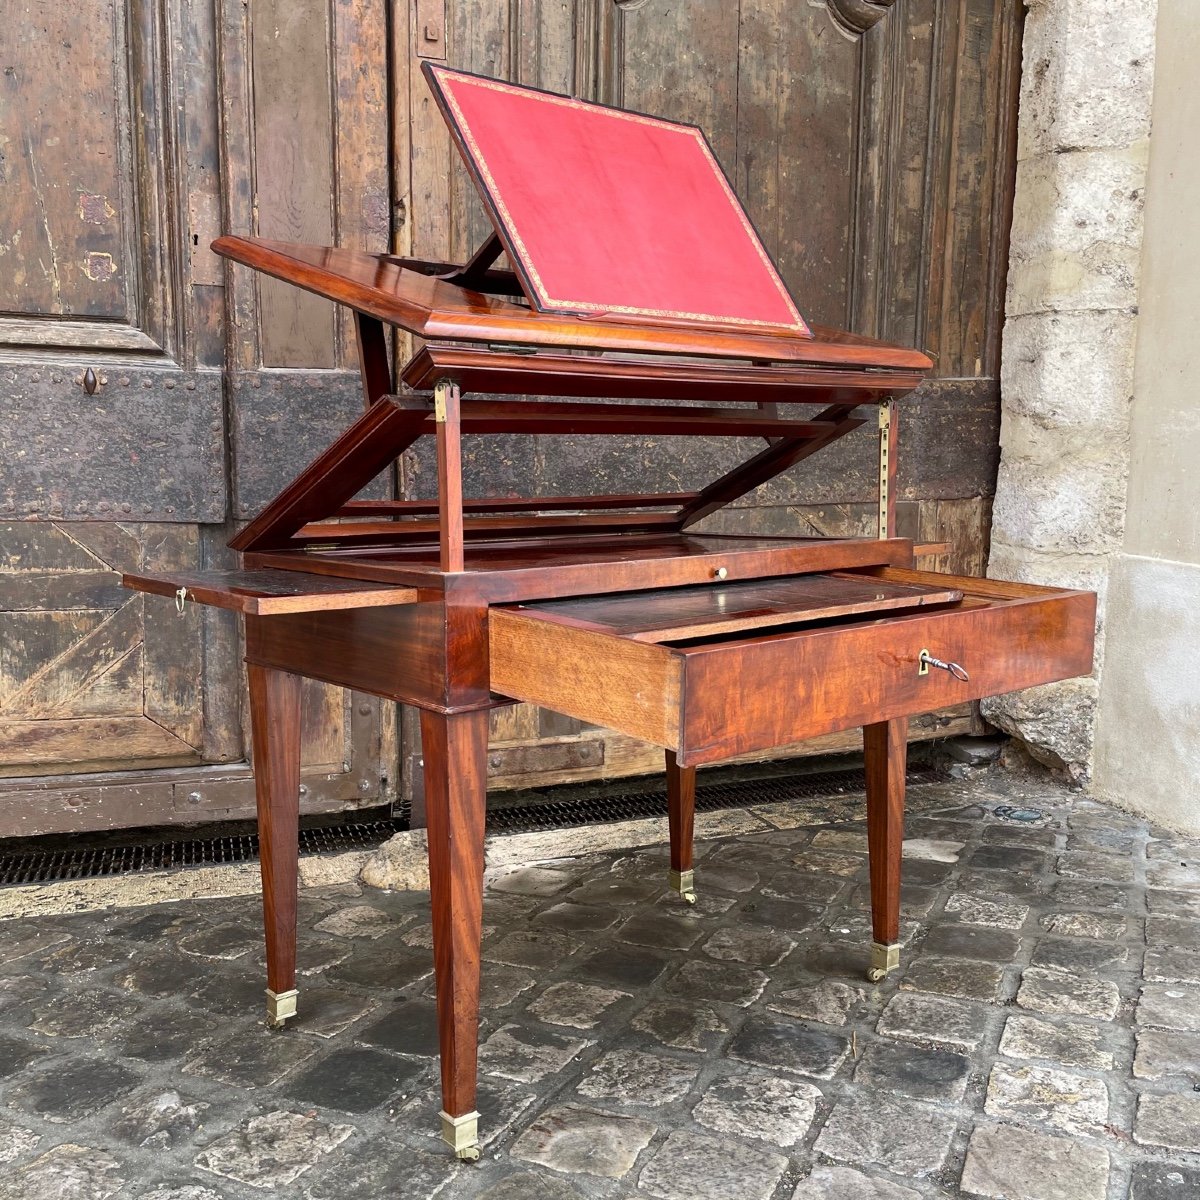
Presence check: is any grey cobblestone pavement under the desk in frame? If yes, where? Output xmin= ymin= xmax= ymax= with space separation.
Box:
xmin=0 ymin=773 xmax=1200 ymax=1200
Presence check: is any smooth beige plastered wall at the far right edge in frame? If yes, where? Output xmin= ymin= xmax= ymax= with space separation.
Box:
xmin=1093 ymin=0 xmax=1200 ymax=834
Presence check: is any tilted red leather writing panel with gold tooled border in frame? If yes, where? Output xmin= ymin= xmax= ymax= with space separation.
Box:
xmin=425 ymin=64 xmax=811 ymax=336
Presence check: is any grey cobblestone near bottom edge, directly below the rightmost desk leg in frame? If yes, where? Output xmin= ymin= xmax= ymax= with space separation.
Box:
xmin=814 ymin=1096 xmax=958 ymax=1178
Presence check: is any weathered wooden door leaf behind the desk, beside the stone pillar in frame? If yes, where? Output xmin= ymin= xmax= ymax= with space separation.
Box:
xmin=392 ymin=0 xmax=1021 ymax=801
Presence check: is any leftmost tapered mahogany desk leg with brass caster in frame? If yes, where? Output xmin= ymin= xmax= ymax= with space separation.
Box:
xmin=247 ymin=665 xmax=300 ymax=1028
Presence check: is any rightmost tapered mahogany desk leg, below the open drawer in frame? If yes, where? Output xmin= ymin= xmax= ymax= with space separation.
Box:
xmin=863 ymin=718 xmax=908 ymax=983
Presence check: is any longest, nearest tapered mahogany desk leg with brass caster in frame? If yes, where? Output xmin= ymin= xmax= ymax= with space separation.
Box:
xmin=421 ymin=712 xmax=487 ymax=1158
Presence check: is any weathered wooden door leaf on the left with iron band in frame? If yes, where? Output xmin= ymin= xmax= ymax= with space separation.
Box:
xmin=0 ymin=0 xmax=395 ymax=836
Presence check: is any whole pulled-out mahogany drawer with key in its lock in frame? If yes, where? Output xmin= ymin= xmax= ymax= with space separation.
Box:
xmin=488 ymin=568 xmax=1096 ymax=766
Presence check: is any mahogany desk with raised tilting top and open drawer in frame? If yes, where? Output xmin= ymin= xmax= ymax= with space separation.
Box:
xmin=125 ymin=63 xmax=1094 ymax=1157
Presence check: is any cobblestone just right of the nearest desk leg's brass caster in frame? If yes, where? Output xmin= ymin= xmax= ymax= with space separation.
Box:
xmin=510 ymin=1104 xmax=658 ymax=1180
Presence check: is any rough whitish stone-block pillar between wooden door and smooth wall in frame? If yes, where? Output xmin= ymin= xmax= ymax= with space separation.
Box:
xmin=984 ymin=0 xmax=1157 ymax=780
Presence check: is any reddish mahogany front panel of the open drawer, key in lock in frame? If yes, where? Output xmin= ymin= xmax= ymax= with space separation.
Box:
xmin=678 ymin=593 xmax=1096 ymax=764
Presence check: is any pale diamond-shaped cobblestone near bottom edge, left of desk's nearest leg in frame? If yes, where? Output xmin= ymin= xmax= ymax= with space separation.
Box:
xmin=196 ymin=1110 xmax=354 ymax=1189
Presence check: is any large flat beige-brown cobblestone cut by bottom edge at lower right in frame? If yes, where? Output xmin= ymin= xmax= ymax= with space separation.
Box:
xmin=961 ymin=1126 xmax=1109 ymax=1200
